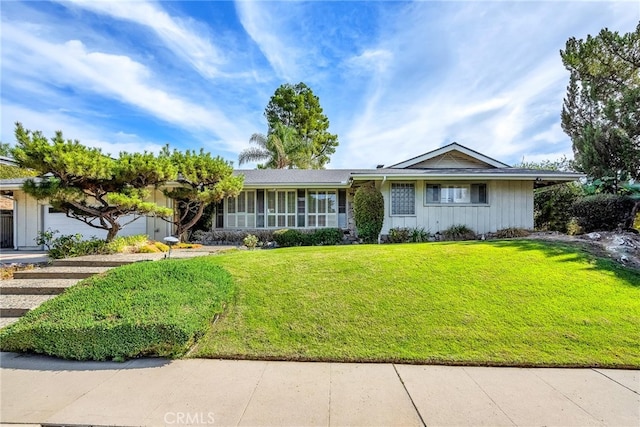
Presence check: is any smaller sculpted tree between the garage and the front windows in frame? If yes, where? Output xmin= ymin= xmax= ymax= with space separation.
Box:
xmin=161 ymin=147 xmax=244 ymax=240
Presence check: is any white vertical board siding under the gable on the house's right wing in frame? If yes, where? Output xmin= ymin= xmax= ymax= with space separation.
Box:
xmin=381 ymin=181 xmax=533 ymax=234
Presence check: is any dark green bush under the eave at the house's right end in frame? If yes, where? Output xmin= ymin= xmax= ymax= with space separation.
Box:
xmin=533 ymin=182 xmax=582 ymax=233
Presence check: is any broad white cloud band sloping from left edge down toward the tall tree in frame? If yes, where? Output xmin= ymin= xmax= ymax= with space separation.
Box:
xmin=2 ymin=21 xmax=252 ymax=154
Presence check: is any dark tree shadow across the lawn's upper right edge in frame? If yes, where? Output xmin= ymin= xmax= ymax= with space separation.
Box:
xmin=489 ymin=239 xmax=640 ymax=288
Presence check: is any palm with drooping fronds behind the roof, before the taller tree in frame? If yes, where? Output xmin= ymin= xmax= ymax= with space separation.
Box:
xmin=238 ymin=123 xmax=311 ymax=169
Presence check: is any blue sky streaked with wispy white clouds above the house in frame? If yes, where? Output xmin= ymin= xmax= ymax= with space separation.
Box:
xmin=0 ymin=0 xmax=640 ymax=168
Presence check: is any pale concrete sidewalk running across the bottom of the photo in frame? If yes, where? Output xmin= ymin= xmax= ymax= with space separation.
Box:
xmin=0 ymin=353 xmax=640 ymax=427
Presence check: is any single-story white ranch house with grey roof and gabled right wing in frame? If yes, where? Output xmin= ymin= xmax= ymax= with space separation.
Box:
xmin=0 ymin=143 xmax=582 ymax=249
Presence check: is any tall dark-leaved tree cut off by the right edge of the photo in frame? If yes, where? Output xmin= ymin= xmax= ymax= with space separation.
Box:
xmin=560 ymin=24 xmax=640 ymax=193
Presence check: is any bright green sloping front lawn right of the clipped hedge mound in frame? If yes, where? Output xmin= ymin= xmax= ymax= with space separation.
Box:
xmin=194 ymin=240 xmax=640 ymax=367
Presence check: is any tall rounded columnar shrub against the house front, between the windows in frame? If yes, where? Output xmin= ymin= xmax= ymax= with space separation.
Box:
xmin=353 ymin=185 xmax=384 ymax=243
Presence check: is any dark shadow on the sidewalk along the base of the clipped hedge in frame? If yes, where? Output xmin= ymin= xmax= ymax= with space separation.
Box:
xmin=0 ymin=352 xmax=171 ymax=372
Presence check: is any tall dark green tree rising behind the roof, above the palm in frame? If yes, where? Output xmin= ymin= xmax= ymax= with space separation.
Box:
xmin=264 ymin=82 xmax=338 ymax=169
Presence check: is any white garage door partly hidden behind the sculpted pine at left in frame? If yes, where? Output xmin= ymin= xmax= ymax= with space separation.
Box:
xmin=44 ymin=206 xmax=147 ymax=239
